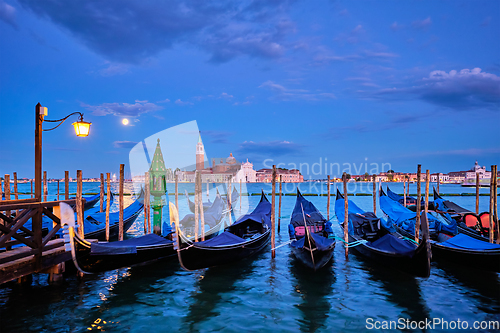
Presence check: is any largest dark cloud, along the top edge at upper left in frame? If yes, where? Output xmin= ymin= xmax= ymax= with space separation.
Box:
xmin=19 ymin=0 xmax=294 ymax=64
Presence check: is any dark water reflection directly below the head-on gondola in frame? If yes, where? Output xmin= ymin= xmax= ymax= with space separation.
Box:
xmin=289 ymin=254 xmax=336 ymax=332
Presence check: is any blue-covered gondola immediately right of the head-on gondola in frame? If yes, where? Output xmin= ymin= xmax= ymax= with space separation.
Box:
xmin=335 ymin=189 xmax=430 ymax=277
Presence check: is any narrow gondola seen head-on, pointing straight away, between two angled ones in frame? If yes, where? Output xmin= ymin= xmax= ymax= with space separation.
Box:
xmin=288 ymin=188 xmax=335 ymax=270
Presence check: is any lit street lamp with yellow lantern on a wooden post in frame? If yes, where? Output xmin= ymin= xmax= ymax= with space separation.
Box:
xmin=35 ymin=103 xmax=92 ymax=202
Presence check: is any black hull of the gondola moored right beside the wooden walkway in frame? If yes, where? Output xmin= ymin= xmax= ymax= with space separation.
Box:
xmin=74 ymin=236 xmax=177 ymax=273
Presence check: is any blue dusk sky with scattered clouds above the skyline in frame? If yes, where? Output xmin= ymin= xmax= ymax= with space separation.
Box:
xmin=0 ymin=0 xmax=500 ymax=178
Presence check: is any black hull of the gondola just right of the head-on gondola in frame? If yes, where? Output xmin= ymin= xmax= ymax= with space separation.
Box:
xmin=341 ymin=227 xmax=431 ymax=277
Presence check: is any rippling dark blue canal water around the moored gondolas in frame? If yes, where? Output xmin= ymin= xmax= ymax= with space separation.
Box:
xmin=0 ymin=183 xmax=500 ymax=333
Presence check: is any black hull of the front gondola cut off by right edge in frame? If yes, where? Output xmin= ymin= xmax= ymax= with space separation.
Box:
xmin=395 ymin=226 xmax=500 ymax=272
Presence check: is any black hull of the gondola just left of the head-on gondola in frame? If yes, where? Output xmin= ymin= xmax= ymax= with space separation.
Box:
xmin=180 ymin=230 xmax=271 ymax=270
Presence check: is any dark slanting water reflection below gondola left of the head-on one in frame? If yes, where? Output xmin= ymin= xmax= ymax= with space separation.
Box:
xmin=184 ymin=258 xmax=256 ymax=331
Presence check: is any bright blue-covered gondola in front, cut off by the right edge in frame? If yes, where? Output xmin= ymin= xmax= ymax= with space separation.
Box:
xmin=380 ymin=190 xmax=500 ymax=272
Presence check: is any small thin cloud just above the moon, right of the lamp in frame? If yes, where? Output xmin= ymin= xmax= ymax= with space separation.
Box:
xmin=80 ymin=100 xmax=163 ymax=117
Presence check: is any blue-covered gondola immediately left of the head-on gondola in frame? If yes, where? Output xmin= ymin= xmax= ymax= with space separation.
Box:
xmin=175 ymin=192 xmax=271 ymax=270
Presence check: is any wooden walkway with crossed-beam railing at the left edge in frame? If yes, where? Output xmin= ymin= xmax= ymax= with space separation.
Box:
xmin=0 ymin=199 xmax=76 ymax=284
